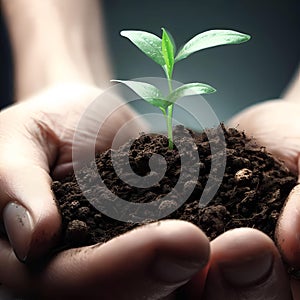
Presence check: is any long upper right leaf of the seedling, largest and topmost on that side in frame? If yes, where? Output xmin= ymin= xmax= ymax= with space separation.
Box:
xmin=175 ymin=29 xmax=251 ymax=62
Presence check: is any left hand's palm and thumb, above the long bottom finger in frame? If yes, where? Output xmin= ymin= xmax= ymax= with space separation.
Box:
xmin=0 ymin=83 xmax=143 ymax=261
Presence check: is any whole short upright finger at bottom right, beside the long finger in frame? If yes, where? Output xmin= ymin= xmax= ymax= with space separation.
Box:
xmin=204 ymin=228 xmax=292 ymax=300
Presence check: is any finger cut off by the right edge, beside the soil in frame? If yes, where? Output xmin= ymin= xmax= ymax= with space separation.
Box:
xmin=276 ymin=184 xmax=300 ymax=268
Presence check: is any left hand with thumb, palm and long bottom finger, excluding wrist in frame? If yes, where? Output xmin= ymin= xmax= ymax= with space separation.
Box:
xmin=0 ymin=84 xmax=209 ymax=299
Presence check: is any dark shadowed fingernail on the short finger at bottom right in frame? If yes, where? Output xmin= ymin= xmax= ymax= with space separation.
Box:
xmin=219 ymin=252 xmax=274 ymax=287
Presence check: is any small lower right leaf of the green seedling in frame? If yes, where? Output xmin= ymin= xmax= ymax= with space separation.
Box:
xmin=167 ymin=82 xmax=216 ymax=103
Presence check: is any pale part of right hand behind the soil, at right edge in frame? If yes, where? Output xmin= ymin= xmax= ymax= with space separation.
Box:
xmin=229 ymin=100 xmax=300 ymax=173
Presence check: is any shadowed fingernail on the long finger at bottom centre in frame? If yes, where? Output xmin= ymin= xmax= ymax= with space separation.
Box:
xmin=152 ymin=258 xmax=206 ymax=284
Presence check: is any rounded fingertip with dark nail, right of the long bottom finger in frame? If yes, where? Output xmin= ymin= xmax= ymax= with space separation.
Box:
xmin=212 ymin=228 xmax=278 ymax=287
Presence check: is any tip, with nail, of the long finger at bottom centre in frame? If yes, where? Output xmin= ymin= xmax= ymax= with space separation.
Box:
xmin=117 ymin=220 xmax=210 ymax=289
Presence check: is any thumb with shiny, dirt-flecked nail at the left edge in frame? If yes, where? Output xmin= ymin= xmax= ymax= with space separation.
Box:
xmin=0 ymin=107 xmax=61 ymax=261
